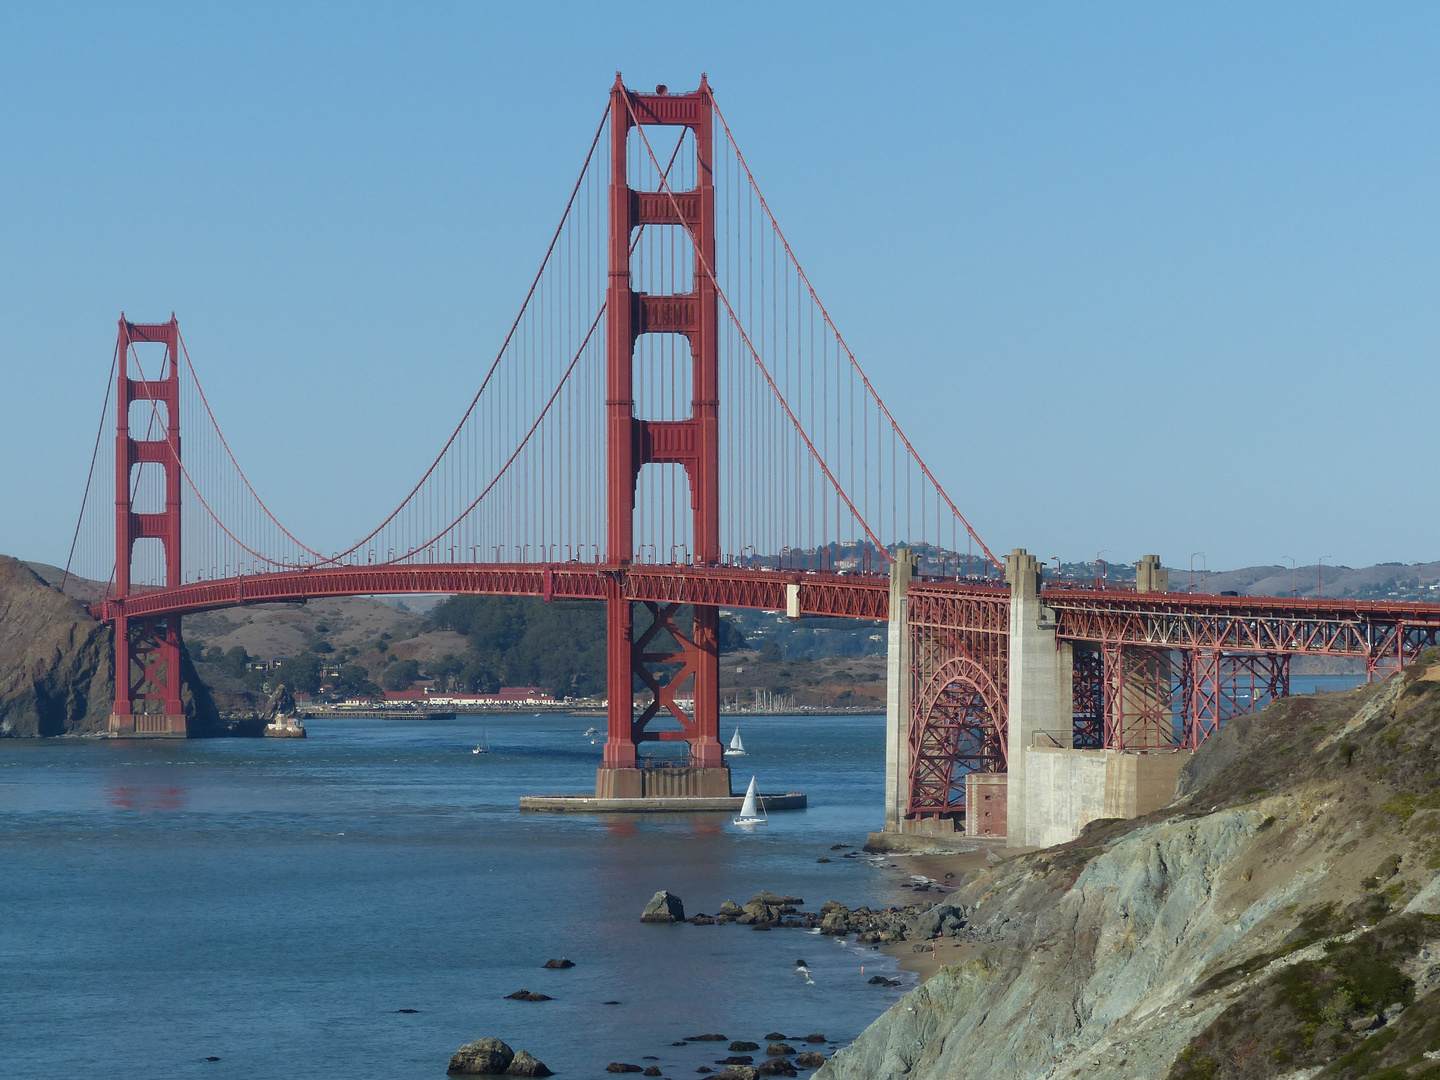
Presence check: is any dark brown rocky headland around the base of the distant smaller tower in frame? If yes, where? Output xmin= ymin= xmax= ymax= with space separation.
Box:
xmin=0 ymin=556 xmax=225 ymax=737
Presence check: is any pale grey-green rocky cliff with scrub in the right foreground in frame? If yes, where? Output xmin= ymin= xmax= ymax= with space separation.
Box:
xmin=816 ymin=667 xmax=1440 ymax=1080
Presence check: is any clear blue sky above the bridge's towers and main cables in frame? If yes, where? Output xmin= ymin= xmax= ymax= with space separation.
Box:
xmin=0 ymin=3 xmax=1440 ymax=567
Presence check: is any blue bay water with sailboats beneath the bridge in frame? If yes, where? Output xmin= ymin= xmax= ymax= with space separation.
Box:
xmin=0 ymin=716 xmax=914 ymax=1080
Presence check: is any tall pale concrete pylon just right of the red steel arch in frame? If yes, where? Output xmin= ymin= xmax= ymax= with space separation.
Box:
xmin=1005 ymin=547 xmax=1074 ymax=845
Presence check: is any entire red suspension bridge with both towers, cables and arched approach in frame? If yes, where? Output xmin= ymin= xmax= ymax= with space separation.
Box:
xmin=66 ymin=78 xmax=1440 ymax=824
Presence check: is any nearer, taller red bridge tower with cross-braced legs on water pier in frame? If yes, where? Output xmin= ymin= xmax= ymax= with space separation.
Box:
xmin=596 ymin=75 xmax=730 ymax=798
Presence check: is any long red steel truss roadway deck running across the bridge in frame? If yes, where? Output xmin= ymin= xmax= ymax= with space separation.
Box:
xmin=91 ymin=563 xmax=1440 ymax=662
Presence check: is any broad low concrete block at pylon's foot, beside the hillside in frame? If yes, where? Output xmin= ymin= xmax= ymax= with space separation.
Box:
xmin=1009 ymin=746 xmax=1191 ymax=847
